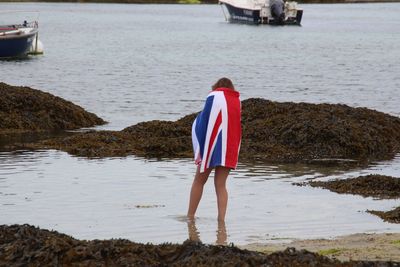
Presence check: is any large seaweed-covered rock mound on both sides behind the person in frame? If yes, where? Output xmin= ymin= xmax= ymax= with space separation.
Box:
xmin=7 ymin=98 xmax=400 ymax=162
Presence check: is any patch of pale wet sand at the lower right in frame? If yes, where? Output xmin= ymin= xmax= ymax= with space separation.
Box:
xmin=243 ymin=233 xmax=400 ymax=266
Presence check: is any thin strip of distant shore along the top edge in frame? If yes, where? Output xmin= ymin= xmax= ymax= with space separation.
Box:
xmin=0 ymin=0 xmax=400 ymax=4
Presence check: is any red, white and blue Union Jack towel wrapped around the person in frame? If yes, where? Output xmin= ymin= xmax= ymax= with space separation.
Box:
xmin=192 ymin=88 xmax=242 ymax=172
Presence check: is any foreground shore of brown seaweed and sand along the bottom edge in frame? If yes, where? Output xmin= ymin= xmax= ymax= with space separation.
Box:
xmin=0 ymin=224 xmax=400 ymax=267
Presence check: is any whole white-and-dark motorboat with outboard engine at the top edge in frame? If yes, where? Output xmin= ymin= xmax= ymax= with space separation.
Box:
xmin=219 ymin=0 xmax=303 ymax=25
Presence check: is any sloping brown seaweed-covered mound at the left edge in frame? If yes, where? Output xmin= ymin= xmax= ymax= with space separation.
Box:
xmin=0 ymin=83 xmax=105 ymax=134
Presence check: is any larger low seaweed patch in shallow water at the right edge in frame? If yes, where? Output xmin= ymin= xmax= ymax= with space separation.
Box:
xmin=307 ymin=174 xmax=400 ymax=199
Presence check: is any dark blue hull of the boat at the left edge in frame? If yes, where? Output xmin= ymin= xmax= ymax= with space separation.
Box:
xmin=0 ymin=30 xmax=37 ymax=58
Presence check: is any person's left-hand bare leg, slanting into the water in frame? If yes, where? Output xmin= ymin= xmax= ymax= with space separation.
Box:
xmin=187 ymin=166 xmax=212 ymax=219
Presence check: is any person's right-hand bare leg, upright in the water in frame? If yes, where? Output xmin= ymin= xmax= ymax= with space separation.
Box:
xmin=214 ymin=166 xmax=230 ymax=222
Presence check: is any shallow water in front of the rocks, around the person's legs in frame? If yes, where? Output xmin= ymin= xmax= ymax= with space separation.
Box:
xmin=0 ymin=151 xmax=400 ymax=244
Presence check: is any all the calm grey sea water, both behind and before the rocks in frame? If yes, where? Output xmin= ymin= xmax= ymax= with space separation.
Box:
xmin=0 ymin=3 xmax=400 ymax=244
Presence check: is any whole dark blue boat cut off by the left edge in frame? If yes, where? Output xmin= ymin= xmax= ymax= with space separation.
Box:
xmin=0 ymin=21 xmax=38 ymax=58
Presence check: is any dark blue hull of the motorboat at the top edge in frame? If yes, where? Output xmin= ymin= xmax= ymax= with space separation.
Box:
xmin=221 ymin=2 xmax=303 ymax=25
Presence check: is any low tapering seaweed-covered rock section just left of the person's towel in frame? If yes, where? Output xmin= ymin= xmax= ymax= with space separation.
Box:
xmin=34 ymin=117 xmax=192 ymax=158
